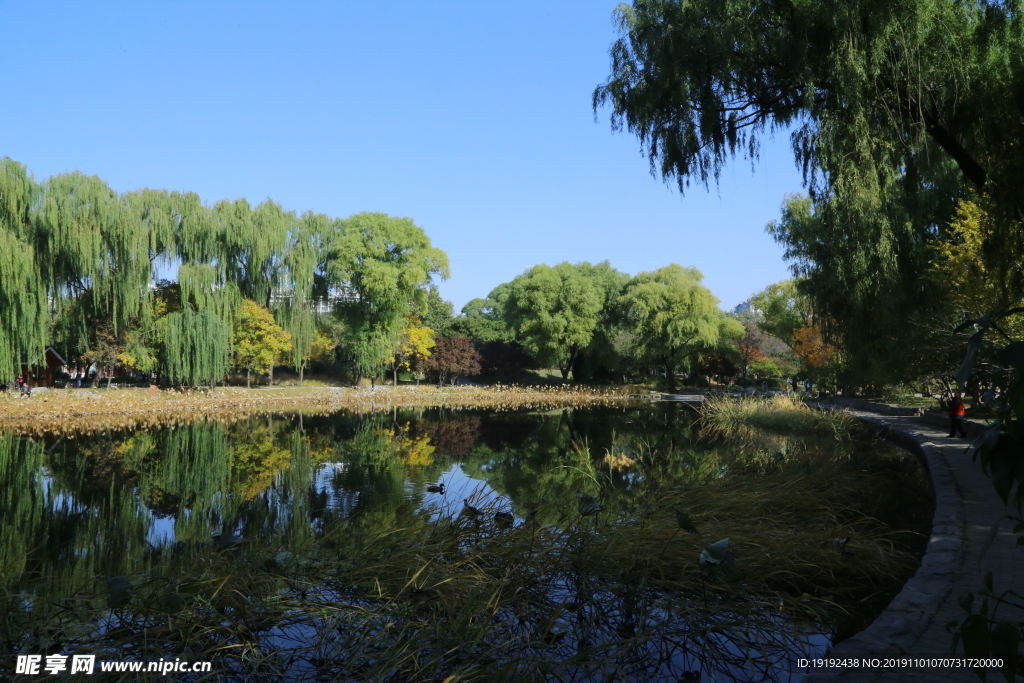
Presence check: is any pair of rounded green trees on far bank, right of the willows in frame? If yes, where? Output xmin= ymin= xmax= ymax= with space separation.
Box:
xmin=444 ymin=261 xmax=743 ymax=388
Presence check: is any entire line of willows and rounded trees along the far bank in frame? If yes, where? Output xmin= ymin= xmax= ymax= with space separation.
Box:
xmin=0 ymin=160 xmax=823 ymax=388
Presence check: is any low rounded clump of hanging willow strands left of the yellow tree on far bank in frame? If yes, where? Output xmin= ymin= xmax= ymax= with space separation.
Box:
xmin=163 ymin=307 xmax=230 ymax=387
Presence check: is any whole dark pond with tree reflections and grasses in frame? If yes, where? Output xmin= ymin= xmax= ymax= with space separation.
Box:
xmin=0 ymin=405 xmax=930 ymax=681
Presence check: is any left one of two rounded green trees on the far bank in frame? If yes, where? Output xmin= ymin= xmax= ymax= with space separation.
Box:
xmin=502 ymin=262 xmax=605 ymax=381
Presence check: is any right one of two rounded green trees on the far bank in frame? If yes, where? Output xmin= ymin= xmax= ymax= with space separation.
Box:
xmin=622 ymin=263 xmax=722 ymax=391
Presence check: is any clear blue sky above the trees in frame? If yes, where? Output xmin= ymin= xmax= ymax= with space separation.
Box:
xmin=6 ymin=0 xmax=801 ymax=310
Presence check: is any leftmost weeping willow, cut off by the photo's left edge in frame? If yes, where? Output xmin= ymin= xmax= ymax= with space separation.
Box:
xmin=0 ymin=158 xmax=47 ymax=384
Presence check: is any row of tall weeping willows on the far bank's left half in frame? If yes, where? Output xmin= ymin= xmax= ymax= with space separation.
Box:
xmin=0 ymin=159 xmax=449 ymax=385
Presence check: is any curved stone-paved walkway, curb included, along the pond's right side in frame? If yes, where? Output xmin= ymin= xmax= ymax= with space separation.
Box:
xmin=807 ymin=411 xmax=1024 ymax=683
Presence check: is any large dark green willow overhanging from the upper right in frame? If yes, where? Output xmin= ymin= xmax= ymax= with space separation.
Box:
xmin=594 ymin=0 xmax=1024 ymax=389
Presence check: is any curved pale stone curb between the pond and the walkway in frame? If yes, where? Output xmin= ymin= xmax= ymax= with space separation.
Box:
xmin=805 ymin=413 xmax=962 ymax=683
